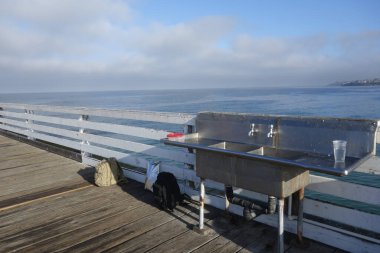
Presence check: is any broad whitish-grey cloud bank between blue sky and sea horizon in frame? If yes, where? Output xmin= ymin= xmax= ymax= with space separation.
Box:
xmin=0 ymin=0 xmax=380 ymax=91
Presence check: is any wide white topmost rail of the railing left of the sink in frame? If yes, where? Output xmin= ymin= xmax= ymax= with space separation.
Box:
xmin=0 ymin=103 xmax=195 ymax=125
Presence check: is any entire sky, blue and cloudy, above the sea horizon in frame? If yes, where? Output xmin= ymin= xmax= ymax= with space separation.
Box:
xmin=0 ymin=0 xmax=380 ymax=92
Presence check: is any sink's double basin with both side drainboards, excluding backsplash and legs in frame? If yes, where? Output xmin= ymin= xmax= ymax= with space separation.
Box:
xmin=164 ymin=133 xmax=363 ymax=198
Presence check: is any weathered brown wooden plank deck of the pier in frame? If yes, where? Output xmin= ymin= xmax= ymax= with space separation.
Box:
xmin=0 ymin=135 xmax=341 ymax=253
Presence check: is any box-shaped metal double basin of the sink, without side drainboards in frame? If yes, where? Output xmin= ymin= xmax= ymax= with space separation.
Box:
xmin=196 ymin=141 xmax=309 ymax=198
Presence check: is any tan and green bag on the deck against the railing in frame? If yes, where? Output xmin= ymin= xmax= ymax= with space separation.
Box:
xmin=95 ymin=157 xmax=126 ymax=186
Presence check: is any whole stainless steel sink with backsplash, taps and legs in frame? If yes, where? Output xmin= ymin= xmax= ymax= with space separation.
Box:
xmin=164 ymin=112 xmax=378 ymax=252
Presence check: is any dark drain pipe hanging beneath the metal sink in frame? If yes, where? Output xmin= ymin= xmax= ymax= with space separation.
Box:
xmin=225 ymin=185 xmax=276 ymax=220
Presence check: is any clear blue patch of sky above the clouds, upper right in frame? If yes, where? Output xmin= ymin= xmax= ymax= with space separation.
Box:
xmin=137 ymin=0 xmax=380 ymax=36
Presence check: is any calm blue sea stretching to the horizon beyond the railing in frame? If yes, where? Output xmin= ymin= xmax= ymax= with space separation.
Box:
xmin=0 ymin=87 xmax=380 ymax=214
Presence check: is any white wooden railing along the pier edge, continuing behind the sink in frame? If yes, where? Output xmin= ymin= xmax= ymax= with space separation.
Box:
xmin=0 ymin=103 xmax=380 ymax=252
